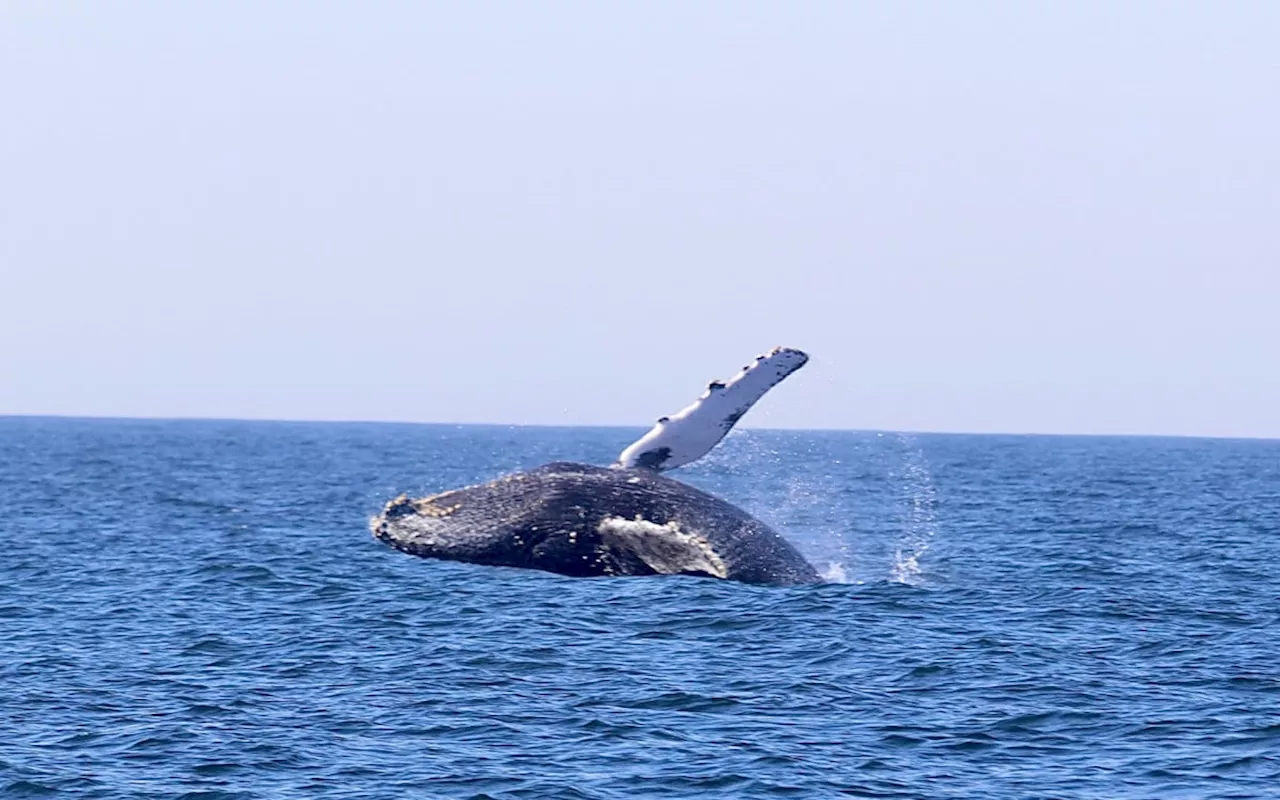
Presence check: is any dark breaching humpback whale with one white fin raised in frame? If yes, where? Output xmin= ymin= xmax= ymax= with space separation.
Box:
xmin=370 ymin=347 xmax=819 ymax=585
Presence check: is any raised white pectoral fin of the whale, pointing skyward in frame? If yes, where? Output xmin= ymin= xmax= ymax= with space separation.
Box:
xmin=614 ymin=347 xmax=809 ymax=471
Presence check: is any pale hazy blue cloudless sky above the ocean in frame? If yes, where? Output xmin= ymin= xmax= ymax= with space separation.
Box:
xmin=0 ymin=0 xmax=1280 ymax=438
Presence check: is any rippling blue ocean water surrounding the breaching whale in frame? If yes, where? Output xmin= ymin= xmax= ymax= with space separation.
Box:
xmin=0 ymin=417 xmax=1280 ymax=799
